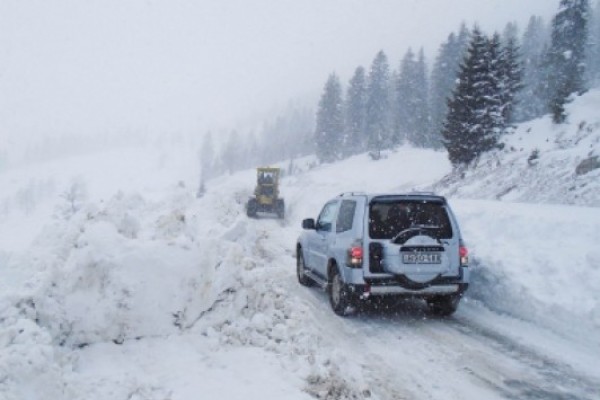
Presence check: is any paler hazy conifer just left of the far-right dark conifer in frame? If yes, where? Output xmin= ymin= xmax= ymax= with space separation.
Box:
xmin=514 ymin=16 xmax=548 ymax=121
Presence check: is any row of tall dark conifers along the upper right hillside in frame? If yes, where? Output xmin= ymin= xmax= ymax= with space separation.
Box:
xmin=314 ymin=0 xmax=600 ymax=165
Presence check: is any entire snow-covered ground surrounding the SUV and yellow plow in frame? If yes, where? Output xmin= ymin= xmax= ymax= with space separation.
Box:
xmin=0 ymin=93 xmax=600 ymax=400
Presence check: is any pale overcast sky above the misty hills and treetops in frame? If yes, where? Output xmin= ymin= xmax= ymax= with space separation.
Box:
xmin=0 ymin=0 xmax=559 ymax=138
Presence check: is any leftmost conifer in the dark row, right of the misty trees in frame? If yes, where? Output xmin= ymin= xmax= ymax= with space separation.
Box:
xmin=315 ymin=73 xmax=344 ymax=162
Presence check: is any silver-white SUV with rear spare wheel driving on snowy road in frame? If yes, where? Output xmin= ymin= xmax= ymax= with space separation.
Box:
xmin=296 ymin=193 xmax=469 ymax=315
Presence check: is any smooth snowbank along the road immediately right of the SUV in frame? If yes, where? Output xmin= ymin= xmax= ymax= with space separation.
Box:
xmin=452 ymin=200 xmax=600 ymax=331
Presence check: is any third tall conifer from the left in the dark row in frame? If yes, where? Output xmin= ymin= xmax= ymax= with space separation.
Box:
xmin=366 ymin=50 xmax=391 ymax=159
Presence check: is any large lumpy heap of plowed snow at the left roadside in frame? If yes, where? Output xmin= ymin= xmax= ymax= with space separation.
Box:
xmin=0 ymin=188 xmax=240 ymax=399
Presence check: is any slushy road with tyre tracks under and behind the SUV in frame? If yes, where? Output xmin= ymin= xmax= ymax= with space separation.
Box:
xmin=226 ymin=214 xmax=600 ymax=400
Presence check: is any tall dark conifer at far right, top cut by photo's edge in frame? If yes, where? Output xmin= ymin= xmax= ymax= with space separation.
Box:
xmin=547 ymin=0 xmax=589 ymax=123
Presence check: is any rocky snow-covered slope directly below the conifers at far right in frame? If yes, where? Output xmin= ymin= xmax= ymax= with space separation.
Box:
xmin=433 ymin=89 xmax=600 ymax=207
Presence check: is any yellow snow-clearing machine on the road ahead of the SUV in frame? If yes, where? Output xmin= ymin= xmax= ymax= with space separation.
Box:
xmin=246 ymin=167 xmax=285 ymax=218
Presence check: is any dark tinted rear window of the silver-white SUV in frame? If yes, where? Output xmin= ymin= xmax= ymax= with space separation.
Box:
xmin=369 ymin=200 xmax=452 ymax=239
